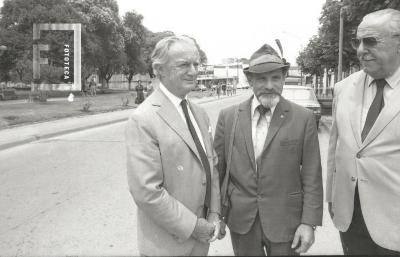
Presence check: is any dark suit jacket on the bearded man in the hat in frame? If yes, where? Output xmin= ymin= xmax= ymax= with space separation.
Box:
xmin=214 ymin=97 xmax=323 ymax=242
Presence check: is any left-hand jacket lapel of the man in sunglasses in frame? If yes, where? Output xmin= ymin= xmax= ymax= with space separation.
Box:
xmin=347 ymin=72 xmax=367 ymax=147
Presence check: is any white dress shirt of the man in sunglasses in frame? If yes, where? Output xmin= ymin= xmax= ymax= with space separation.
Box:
xmin=361 ymin=67 xmax=400 ymax=131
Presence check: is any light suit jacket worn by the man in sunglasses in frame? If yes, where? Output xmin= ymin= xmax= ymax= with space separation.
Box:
xmin=326 ymin=71 xmax=400 ymax=251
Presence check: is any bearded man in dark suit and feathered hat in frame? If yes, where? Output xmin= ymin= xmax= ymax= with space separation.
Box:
xmin=214 ymin=44 xmax=323 ymax=256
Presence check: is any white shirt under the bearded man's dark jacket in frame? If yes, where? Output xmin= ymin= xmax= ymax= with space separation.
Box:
xmin=251 ymin=95 xmax=276 ymax=158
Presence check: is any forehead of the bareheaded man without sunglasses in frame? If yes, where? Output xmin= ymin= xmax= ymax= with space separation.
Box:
xmin=168 ymin=41 xmax=200 ymax=62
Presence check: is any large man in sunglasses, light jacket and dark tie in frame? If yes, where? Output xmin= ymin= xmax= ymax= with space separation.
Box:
xmin=326 ymin=9 xmax=400 ymax=255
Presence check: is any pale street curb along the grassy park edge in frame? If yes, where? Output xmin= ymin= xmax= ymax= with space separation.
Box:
xmin=0 ymin=91 xmax=247 ymax=151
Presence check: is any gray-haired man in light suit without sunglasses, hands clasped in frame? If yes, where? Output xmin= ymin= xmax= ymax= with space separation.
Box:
xmin=126 ymin=36 xmax=220 ymax=256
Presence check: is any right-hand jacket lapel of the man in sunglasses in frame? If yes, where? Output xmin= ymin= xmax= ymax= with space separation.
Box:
xmin=361 ymin=82 xmax=400 ymax=148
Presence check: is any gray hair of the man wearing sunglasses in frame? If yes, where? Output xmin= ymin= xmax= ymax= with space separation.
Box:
xmin=362 ymin=8 xmax=400 ymax=35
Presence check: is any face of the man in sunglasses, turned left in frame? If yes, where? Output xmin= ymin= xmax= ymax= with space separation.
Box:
xmin=357 ymin=19 xmax=400 ymax=79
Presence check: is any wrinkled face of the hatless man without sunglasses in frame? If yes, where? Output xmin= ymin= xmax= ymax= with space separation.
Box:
xmin=159 ymin=42 xmax=200 ymax=99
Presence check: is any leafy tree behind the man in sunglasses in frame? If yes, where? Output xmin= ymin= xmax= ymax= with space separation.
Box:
xmin=297 ymin=0 xmax=400 ymax=78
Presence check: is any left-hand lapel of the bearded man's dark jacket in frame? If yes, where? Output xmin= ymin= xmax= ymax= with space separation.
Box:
xmin=238 ymin=97 xmax=256 ymax=170
